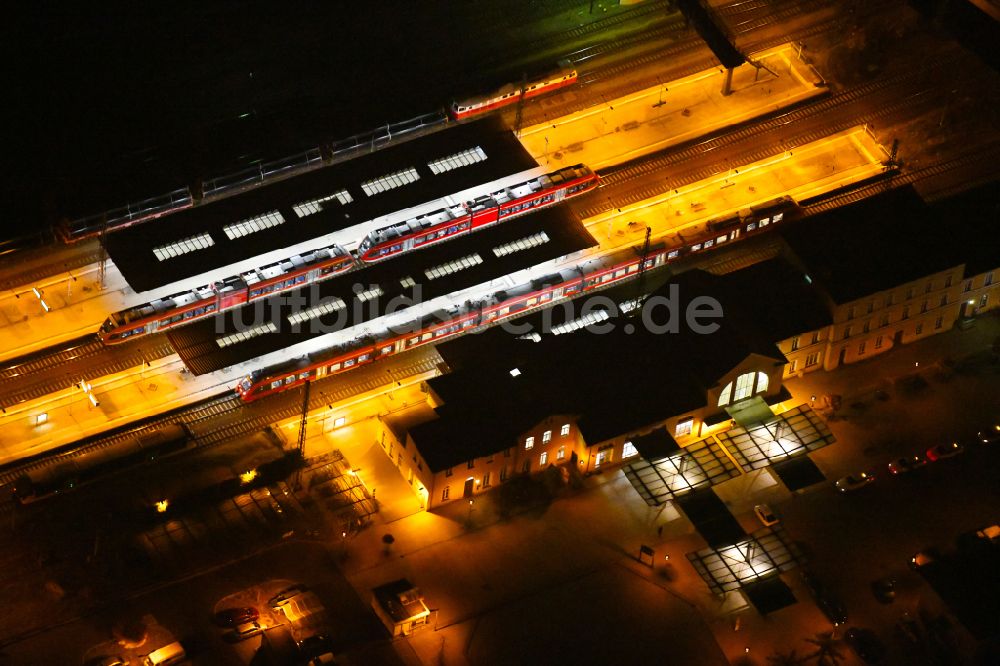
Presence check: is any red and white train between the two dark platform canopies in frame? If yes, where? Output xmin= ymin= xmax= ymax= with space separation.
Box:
xmin=98 ymin=164 xmax=600 ymax=344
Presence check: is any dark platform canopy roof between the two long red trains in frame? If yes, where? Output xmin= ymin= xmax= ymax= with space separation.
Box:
xmin=168 ymin=206 xmax=597 ymax=375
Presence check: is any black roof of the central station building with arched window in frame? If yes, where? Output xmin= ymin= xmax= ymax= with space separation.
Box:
xmin=411 ymin=271 xmax=784 ymax=471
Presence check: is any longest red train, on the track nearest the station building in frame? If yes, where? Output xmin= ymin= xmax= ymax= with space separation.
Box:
xmin=236 ymin=197 xmax=799 ymax=402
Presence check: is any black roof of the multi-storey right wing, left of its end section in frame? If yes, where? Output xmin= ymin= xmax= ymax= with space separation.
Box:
xmin=779 ymin=186 xmax=948 ymax=304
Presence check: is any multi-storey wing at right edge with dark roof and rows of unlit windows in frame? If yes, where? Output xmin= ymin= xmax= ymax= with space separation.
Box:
xmin=778 ymin=183 xmax=1000 ymax=377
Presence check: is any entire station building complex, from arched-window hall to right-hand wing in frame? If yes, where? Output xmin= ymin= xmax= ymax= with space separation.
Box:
xmin=404 ymin=184 xmax=1000 ymax=508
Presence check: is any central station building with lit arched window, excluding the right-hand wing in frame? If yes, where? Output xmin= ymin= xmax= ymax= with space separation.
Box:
xmin=407 ymin=271 xmax=819 ymax=508
